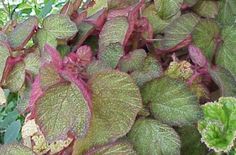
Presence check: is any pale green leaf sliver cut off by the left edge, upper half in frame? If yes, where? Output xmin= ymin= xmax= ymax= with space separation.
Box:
xmin=0 ymin=42 xmax=10 ymax=81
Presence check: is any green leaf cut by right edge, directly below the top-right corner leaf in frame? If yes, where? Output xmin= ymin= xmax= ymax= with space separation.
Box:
xmin=216 ymin=27 xmax=236 ymax=77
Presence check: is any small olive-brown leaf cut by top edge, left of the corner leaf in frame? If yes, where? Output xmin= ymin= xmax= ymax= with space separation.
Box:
xmin=193 ymin=0 xmax=219 ymax=18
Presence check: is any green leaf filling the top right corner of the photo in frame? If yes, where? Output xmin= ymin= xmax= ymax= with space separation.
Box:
xmin=217 ymin=0 xmax=236 ymax=26
